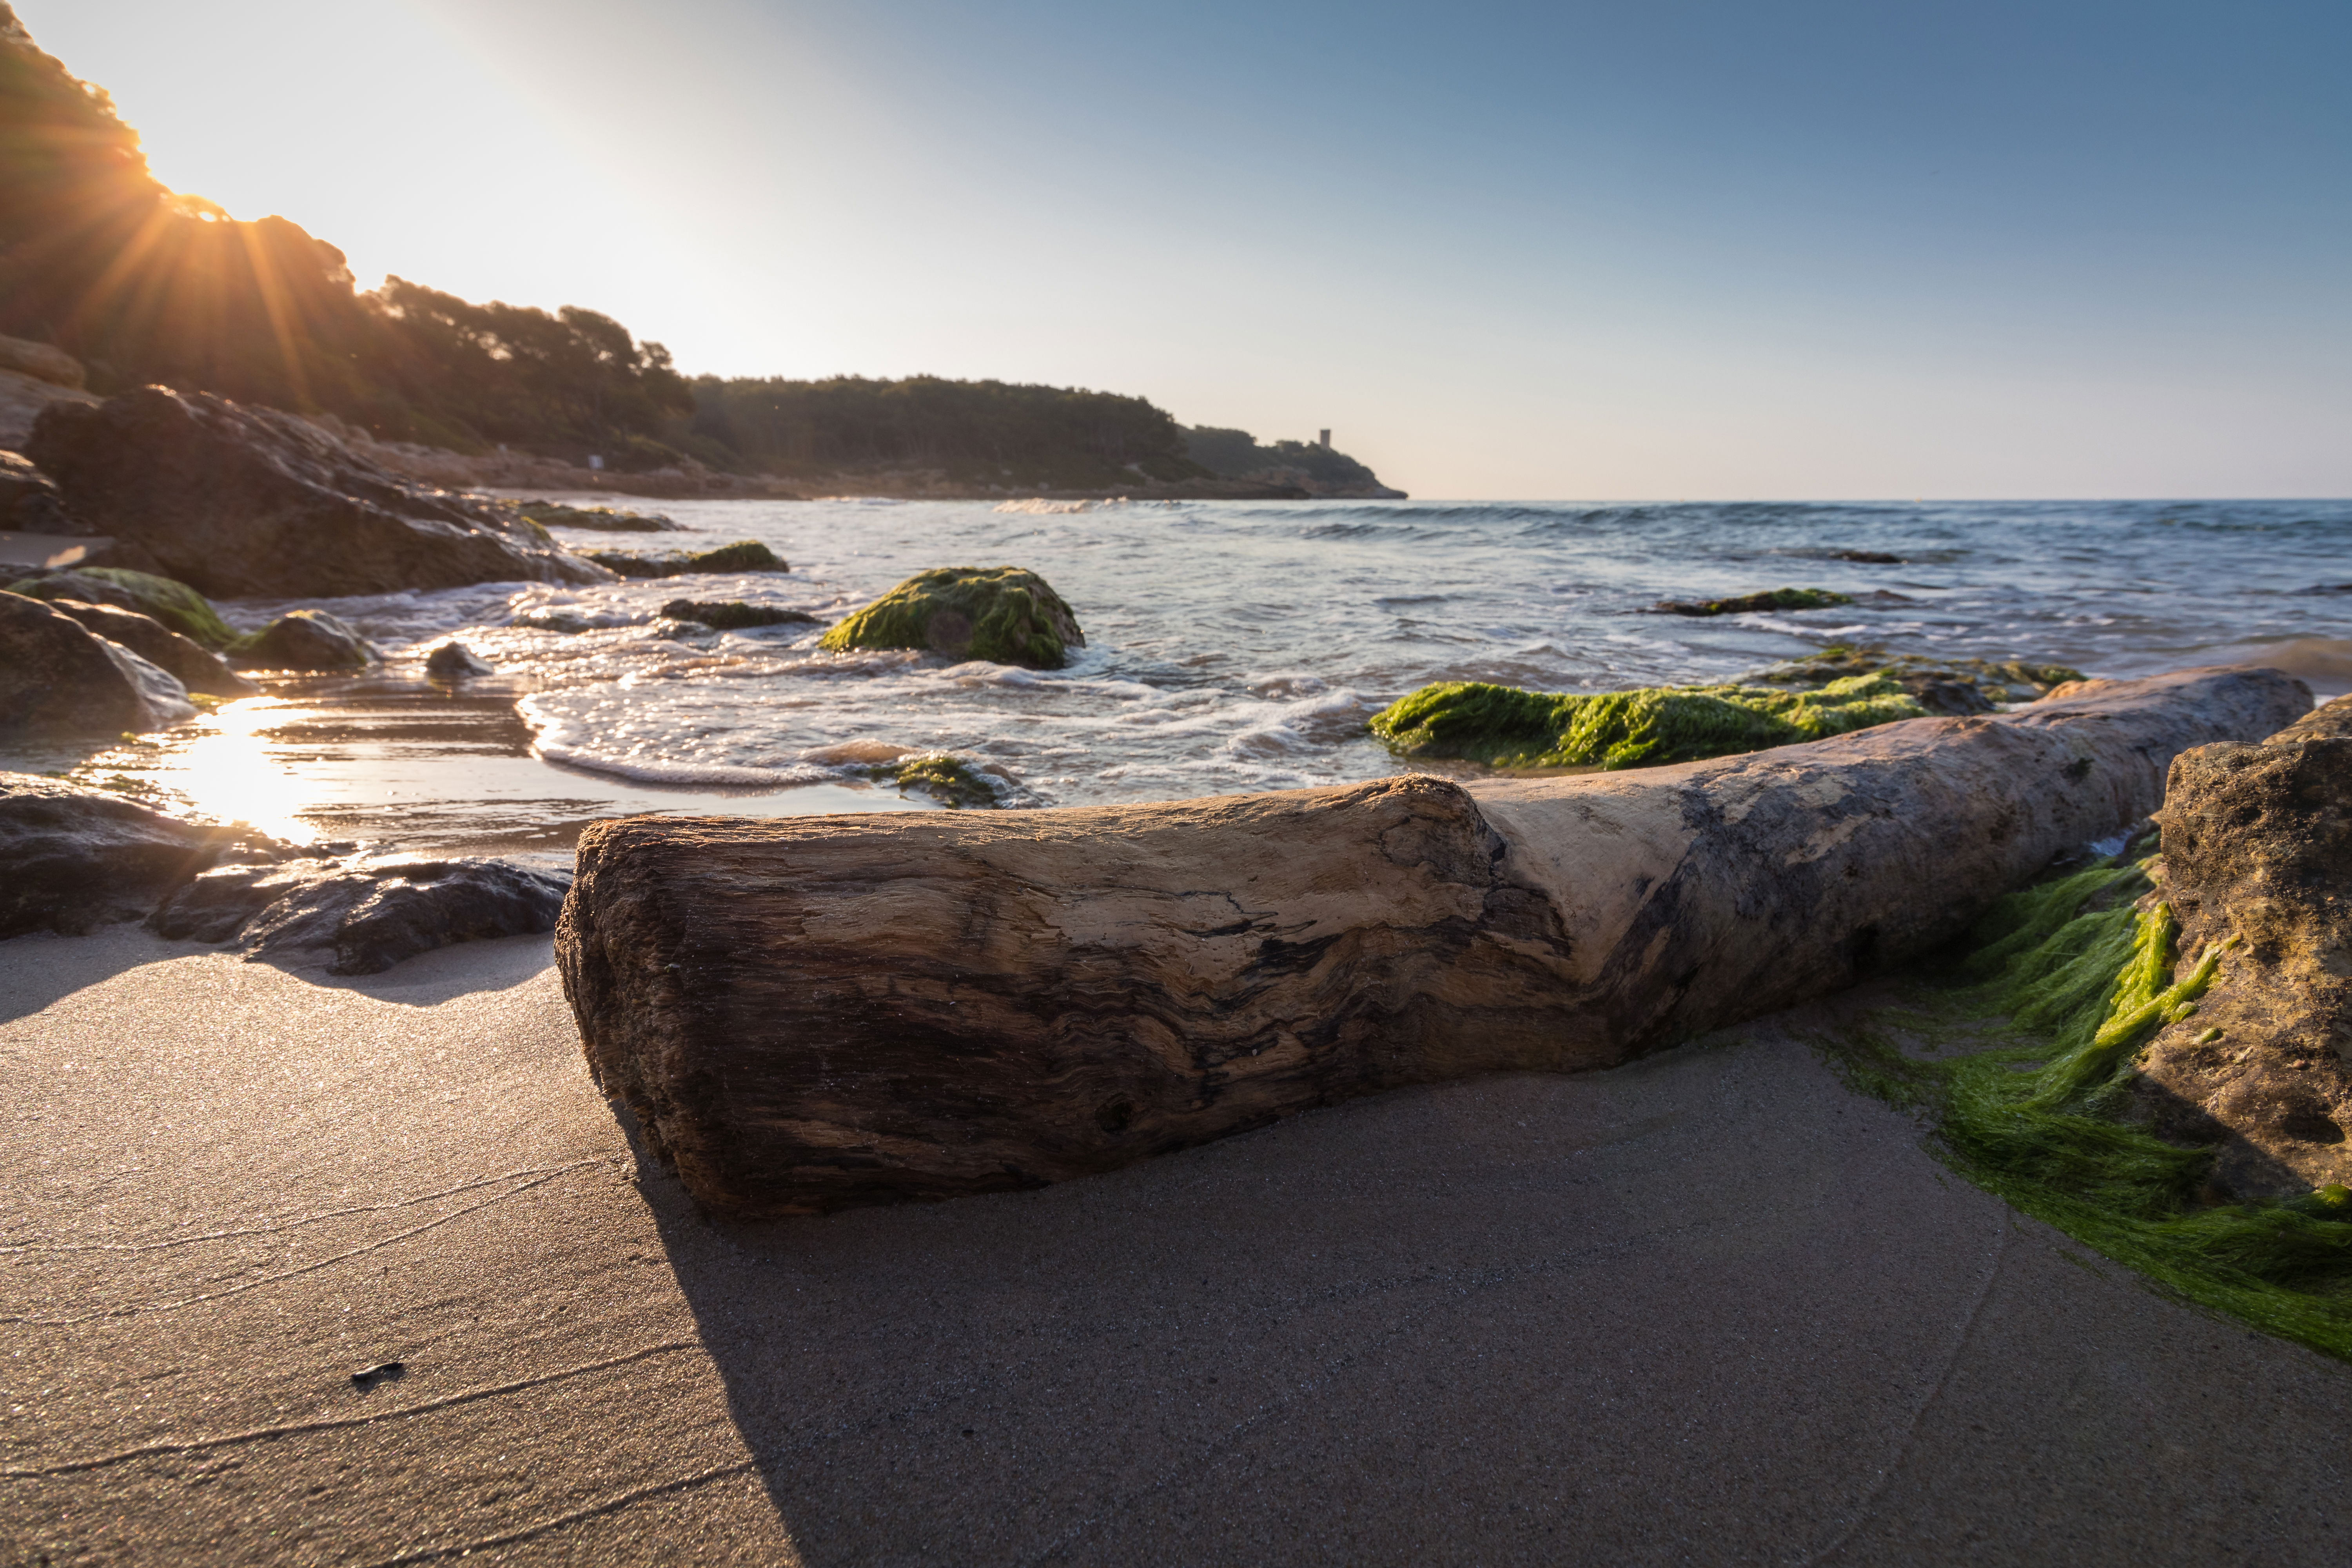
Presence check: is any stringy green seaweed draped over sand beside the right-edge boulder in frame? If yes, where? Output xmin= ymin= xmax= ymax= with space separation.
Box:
xmin=1823 ymin=863 xmax=2352 ymax=1361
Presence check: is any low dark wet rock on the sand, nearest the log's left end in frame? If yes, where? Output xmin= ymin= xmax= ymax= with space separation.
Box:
xmin=230 ymin=858 xmax=572 ymax=976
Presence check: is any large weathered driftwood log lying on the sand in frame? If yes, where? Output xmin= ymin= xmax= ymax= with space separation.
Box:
xmin=557 ymin=670 xmax=2310 ymax=1215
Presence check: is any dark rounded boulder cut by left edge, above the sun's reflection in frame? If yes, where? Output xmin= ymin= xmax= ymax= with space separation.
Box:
xmin=0 ymin=592 xmax=195 ymax=736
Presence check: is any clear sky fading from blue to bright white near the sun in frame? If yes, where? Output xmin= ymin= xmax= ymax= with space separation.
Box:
xmin=16 ymin=0 xmax=2352 ymax=501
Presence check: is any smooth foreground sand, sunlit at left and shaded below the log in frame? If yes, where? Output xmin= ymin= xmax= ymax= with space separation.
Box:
xmin=0 ymin=931 xmax=2352 ymax=1566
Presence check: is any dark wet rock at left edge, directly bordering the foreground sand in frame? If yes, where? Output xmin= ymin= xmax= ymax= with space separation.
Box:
xmin=0 ymin=773 xmax=289 ymax=938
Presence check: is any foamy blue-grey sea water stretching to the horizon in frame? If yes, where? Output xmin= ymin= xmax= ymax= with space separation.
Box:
xmin=230 ymin=498 xmax=2352 ymax=809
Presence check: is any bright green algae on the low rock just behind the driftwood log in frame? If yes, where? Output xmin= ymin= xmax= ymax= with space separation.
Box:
xmin=1371 ymin=675 xmax=1926 ymax=769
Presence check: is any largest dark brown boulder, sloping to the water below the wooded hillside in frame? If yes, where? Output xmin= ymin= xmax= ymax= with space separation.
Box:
xmin=26 ymin=386 xmax=612 ymax=599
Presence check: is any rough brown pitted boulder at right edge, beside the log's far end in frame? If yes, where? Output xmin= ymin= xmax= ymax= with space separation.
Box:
xmin=2138 ymin=698 xmax=2352 ymax=1199
